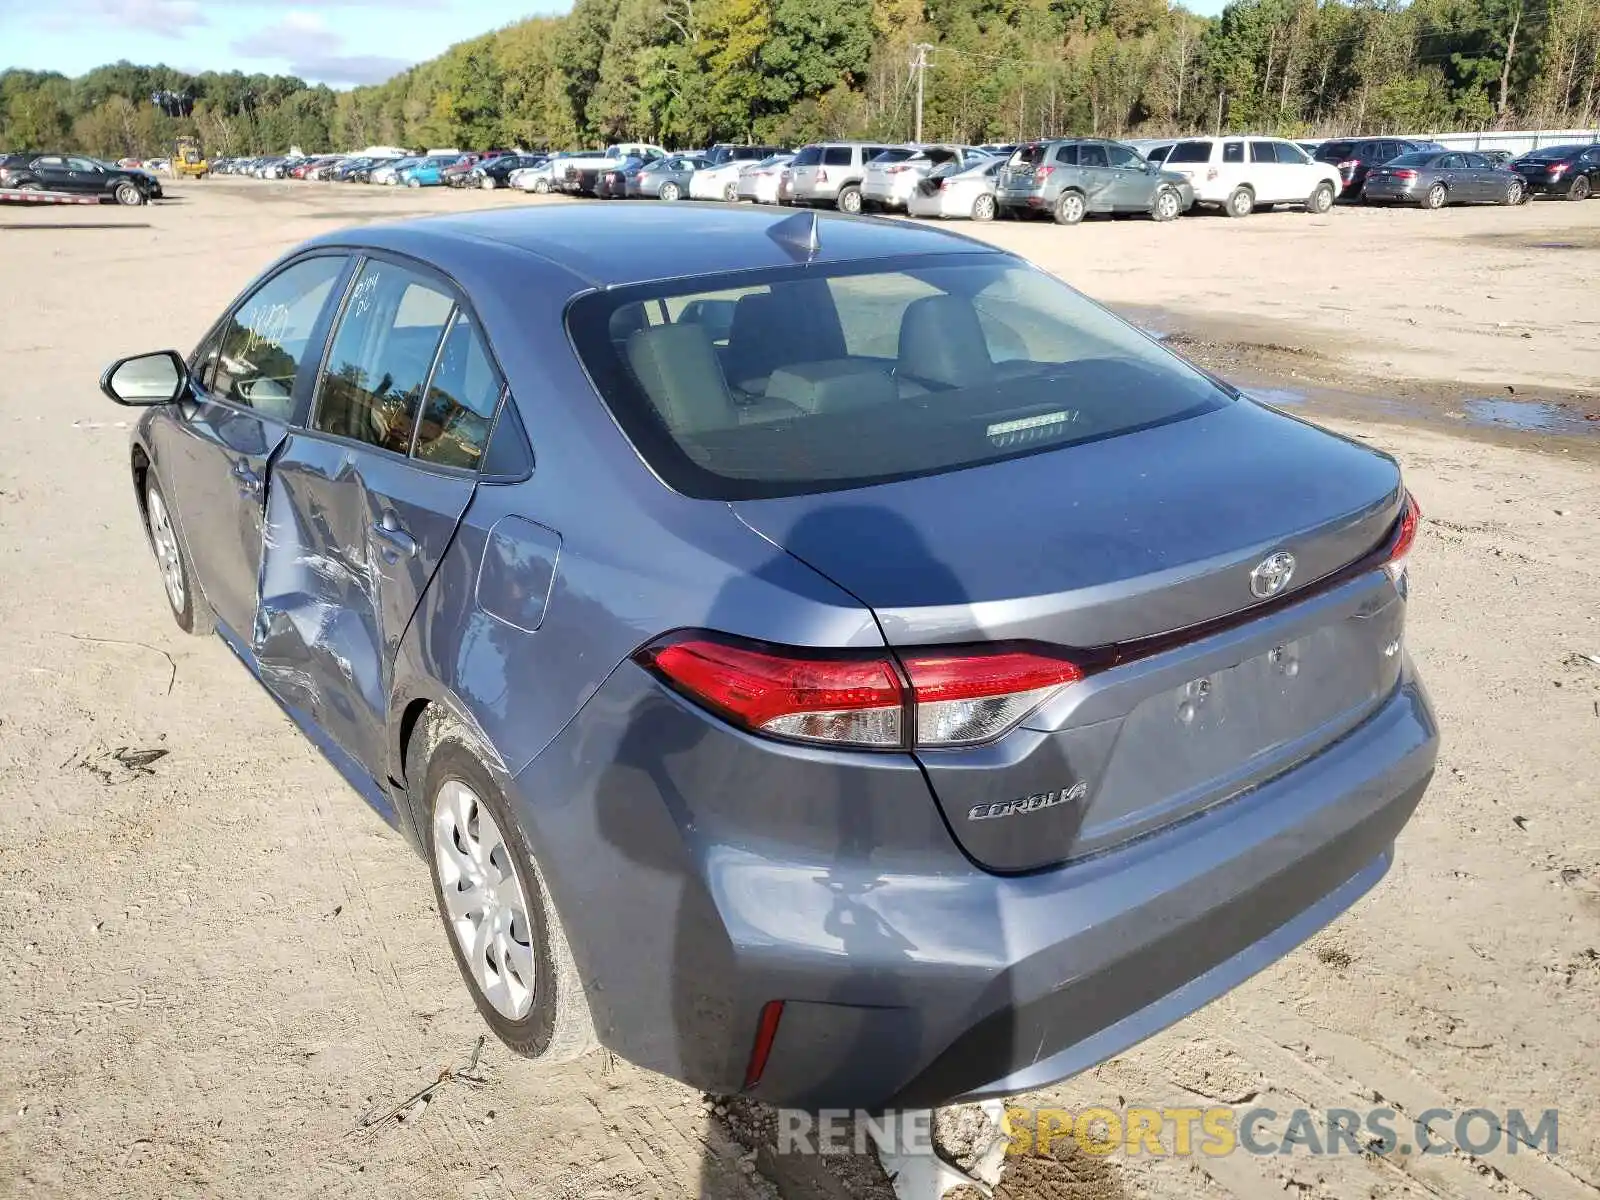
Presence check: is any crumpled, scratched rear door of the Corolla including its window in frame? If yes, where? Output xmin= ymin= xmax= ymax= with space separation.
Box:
xmin=253 ymin=258 xmax=477 ymax=782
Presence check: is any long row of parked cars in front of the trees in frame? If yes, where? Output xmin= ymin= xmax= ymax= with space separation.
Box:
xmin=213 ymin=134 xmax=1600 ymax=226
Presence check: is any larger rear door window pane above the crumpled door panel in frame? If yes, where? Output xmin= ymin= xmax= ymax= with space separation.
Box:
xmin=312 ymin=259 xmax=454 ymax=454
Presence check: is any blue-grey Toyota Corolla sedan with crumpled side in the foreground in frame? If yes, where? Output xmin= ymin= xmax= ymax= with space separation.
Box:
xmin=102 ymin=205 xmax=1437 ymax=1107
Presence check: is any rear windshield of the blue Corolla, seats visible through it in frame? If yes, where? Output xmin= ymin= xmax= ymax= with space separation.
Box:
xmin=568 ymin=253 xmax=1230 ymax=499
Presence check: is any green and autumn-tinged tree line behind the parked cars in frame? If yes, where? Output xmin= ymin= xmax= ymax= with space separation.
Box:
xmin=0 ymin=0 xmax=1600 ymax=157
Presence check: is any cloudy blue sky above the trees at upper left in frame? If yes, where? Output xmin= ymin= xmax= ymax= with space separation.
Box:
xmin=0 ymin=0 xmax=570 ymax=86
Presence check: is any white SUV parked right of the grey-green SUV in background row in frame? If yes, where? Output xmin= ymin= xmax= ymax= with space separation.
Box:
xmin=1163 ymin=138 xmax=1344 ymax=216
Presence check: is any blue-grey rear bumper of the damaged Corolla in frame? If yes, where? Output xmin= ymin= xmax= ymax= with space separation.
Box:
xmin=510 ymin=664 xmax=1438 ymax=1107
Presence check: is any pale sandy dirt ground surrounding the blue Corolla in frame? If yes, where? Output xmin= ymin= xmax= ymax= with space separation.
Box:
xmin=0 ymin=181 xmax=1600 ymax=1200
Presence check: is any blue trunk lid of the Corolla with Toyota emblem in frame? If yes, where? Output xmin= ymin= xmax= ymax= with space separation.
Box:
xmin=733 ymin=400 xmax=1403 ymax=870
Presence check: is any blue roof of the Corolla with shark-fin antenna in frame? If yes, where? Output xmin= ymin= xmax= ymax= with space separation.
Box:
xmin=314 ymin=203 xmax=997 ymax=286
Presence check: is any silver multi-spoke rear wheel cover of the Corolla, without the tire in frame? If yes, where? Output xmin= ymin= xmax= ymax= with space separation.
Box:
xmin=434 ymin=779 xmax=536 ymax=1021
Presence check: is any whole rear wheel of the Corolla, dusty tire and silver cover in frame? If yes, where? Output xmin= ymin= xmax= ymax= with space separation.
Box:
xmin=419 ymin=706 xmax=597 ymax=1062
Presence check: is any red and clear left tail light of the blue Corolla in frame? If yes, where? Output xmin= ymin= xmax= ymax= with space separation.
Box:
xmin=635 ymin=632 xmax=1085 ymax=750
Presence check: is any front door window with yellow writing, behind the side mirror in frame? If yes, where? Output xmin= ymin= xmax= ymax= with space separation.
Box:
xmin=210 ymin=254 xmax=346 ymax=421
